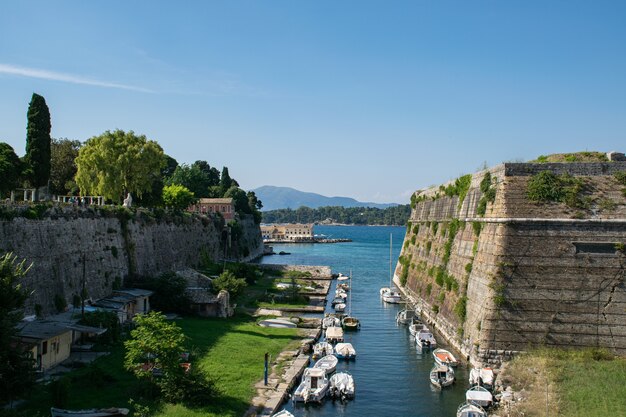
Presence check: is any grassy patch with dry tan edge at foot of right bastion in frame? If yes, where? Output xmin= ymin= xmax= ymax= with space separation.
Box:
xmin=503 ymin=349 xmax=626 ymax=417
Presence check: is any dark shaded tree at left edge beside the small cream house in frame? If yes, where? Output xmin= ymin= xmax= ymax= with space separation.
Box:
xmin=0 ymin=253 xmax=34 ymax=403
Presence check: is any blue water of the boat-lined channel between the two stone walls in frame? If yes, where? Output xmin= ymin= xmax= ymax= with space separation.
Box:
xmin=261 ymin=226 xmax=468 ymax=417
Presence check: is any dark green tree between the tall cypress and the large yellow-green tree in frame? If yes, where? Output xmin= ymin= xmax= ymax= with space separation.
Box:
xmin=50 ymin=139 xmax=81 ymax=195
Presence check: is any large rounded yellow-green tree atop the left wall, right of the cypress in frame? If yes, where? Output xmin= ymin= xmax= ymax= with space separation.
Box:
xmin=76 ymin=130 xmax=165 ymax=202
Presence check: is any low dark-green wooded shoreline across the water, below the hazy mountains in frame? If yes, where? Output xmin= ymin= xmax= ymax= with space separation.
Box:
xmin=262 ymin=204 xmax=411 ymax=226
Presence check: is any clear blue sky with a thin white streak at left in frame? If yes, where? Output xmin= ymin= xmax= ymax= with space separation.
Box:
xmin=0 ymin=0 xmax=626 ymax=203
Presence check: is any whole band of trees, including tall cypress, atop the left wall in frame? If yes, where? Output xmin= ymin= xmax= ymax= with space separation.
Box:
xmin=0 ymin=93 xmax=263 ymax=223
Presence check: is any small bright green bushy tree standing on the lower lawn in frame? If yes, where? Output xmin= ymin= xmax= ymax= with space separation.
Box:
xmin=124 ymin=311 xmax=187 ymax=385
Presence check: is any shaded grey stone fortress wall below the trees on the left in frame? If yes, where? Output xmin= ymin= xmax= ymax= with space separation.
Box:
xmin=0 ymin=207 xmax=263 ymax=313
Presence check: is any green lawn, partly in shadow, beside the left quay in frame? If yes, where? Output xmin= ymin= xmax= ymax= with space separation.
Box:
xmin=22 ymin=315 xmax=300 ymax=417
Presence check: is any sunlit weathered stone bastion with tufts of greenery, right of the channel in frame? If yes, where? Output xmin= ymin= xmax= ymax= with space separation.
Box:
xmin=394 ymin=162 xmax=626 ymax=363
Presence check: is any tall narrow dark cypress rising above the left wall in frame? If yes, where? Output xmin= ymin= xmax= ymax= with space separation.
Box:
xmin=25 ymin=93 xmax=52 ymax=187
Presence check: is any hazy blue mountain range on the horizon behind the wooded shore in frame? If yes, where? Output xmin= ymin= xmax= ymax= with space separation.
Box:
xmin=252 ymin=185 xmax=398 ymax=211
